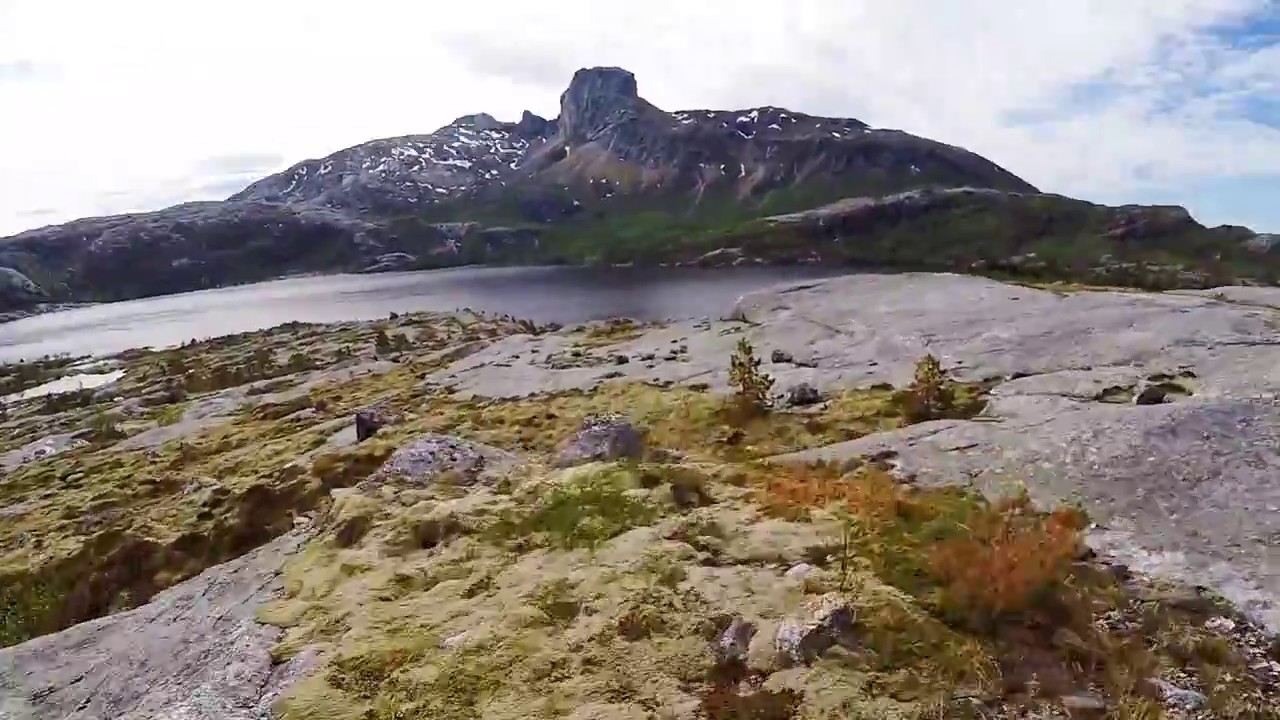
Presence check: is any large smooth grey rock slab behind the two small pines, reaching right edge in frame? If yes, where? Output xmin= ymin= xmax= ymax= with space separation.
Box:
xmin=433 ymin=274 xmax=1280 ymax=629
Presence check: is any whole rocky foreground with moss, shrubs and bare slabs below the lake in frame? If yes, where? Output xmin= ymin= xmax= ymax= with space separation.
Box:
xmin=0 ymin=274 xmax=1280 ymax=720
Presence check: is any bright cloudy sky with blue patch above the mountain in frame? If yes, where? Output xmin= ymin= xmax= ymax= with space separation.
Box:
xmin=0 ymin=0 xmax=1280 ymax=234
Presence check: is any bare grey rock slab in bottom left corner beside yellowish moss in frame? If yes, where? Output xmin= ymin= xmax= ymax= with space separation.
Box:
xmin=0 ymin=533 xmax=315 ymax=720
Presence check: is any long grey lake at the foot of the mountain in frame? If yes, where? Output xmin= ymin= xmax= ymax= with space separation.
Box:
xmin=0 ymin=266 xmax=849 ymax=363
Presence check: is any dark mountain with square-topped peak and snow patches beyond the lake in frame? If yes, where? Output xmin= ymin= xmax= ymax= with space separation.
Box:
xmin=0 ymin=68 xmax=1280 ymax=310
